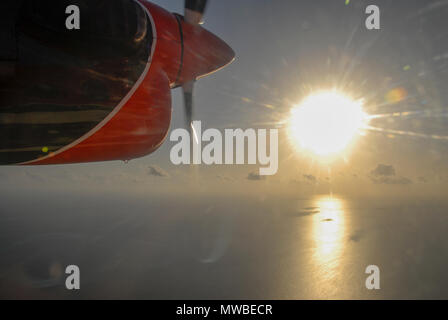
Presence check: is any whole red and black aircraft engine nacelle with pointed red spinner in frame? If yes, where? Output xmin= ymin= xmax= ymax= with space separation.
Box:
xmin=0 ymin=0 xmax=234 ymax=165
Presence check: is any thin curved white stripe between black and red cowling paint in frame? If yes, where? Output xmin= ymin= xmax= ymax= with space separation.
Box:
xmin=20 ymin=0 xmax=157 ymax=165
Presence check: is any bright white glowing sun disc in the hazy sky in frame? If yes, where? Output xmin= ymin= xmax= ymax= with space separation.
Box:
xmin=289 ymin=91 xmax=368 ymax=157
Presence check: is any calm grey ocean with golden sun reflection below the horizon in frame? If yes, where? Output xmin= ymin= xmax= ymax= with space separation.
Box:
xmin=0 ymin=192 xmax=448 ymax=299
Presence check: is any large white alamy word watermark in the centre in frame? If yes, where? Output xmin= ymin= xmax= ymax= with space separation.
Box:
xmin=170 ymin=121 xmax=278 ymax=175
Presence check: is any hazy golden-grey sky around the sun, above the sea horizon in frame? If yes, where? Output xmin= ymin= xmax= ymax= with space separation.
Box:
xmin=0 ymin=0 xmax=448 ymax=197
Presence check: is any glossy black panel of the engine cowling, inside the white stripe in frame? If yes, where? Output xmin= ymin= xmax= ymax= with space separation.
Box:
xmin=0 ymin=0 xmax=153 ymax=164
